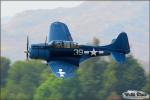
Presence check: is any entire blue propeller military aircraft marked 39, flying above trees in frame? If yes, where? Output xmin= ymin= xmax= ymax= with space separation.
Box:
xmin=25 ymin=22 xmax=130 ymax=78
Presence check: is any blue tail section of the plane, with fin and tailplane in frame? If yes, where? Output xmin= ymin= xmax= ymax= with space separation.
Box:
xmin=108 ymin=32 xmax=130 ymax=63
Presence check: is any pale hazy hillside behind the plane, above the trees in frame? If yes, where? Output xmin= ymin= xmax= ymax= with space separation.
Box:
xmin=1 ymin=1 xmax=149 ymax=70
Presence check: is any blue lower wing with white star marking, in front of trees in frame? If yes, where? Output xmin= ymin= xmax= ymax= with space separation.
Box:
xmin=48 ymin=61 xmax=78 ymax=78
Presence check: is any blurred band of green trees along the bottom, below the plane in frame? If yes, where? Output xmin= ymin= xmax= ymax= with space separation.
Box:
xmin=0 ymin=39 xmax=150 ymax=100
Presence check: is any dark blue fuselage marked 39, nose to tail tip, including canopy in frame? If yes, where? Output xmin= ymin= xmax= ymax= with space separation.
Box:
xmin=29 ymin=41 xmax=129 ymax=65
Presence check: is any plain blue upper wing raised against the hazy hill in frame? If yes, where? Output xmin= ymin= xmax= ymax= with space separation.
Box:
xmin=48 ymin=22 xmax=73 ymax=42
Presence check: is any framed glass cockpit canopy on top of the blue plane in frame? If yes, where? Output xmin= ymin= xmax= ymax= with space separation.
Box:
xmin=48 ymin=40 xmax=79 ymax=48
